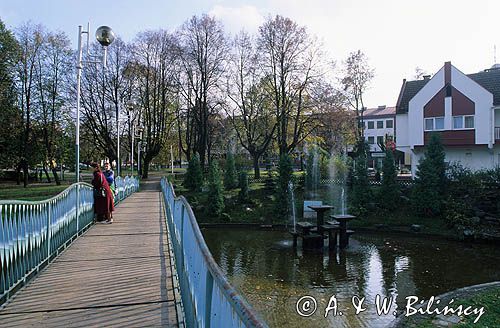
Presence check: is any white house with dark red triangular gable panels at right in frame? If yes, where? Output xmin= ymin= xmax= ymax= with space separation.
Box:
xmin=395 ymin=62 xmax=500 ymax=175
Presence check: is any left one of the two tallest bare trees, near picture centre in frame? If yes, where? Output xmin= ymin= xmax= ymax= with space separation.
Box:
xmin=176 ymin=15 xmax=229 ymax=164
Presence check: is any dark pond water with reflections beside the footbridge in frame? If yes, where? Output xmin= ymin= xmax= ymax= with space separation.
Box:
xmin=203 ymin=228 xmax=500 ymax=328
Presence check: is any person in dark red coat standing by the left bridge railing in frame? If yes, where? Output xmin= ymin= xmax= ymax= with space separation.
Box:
xmin=90 ymin=163 xmax=115 ymax=223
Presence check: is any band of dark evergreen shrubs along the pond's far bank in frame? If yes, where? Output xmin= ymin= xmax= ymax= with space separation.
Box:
xmin=178 ymin=136 xmax=500 ymax=243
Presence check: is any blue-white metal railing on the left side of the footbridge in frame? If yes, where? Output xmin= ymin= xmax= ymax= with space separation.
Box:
xmin=0 ymin=177 xmax=139 ymax=305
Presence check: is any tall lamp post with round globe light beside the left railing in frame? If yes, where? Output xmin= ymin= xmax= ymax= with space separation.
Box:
xmin=75 ymin=24 xmax=115 ymax=182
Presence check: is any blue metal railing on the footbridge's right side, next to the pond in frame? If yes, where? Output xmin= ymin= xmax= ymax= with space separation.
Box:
xmin=161 ymin=178 xmax=267 ymax=327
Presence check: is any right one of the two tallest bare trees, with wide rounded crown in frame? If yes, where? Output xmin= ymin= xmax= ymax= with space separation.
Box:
xmin=258 ymin=15 xmax=322 ymax=154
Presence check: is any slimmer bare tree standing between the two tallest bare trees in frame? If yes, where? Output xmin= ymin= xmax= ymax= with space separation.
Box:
xmin=225 ymin=32 xmax=277 ymax=179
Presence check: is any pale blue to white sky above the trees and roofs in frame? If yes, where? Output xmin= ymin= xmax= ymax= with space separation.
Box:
xmin=0 ymin=0 xmax=500 ymax=107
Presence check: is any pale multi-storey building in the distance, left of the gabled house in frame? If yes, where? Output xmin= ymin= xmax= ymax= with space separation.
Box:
xmin=361 ymin=105 xmax=396 ymax=168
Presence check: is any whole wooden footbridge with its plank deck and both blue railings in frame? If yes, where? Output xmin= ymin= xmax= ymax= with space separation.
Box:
xmin=0 ymin=180 xmax=266 ymax=327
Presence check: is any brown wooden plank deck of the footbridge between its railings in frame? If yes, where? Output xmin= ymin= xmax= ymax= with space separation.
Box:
xmin=0 ymin=181 xmax=178 ymax=327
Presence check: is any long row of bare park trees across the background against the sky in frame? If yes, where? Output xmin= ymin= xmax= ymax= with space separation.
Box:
xmin=0 ymin=15 xmax=364 ymax=188
